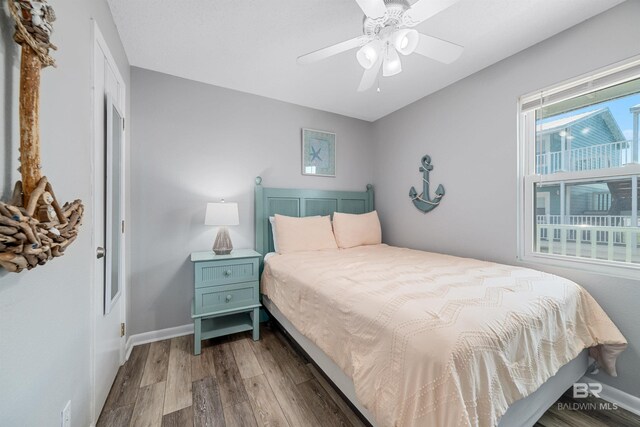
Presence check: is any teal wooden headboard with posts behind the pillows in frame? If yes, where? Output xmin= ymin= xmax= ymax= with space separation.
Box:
xmin=255 ymin=177 xmax=374 ymax=255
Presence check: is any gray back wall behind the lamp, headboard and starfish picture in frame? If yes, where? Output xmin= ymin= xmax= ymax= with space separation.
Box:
xmin=128 ymin=68 xmax=373 ymax=334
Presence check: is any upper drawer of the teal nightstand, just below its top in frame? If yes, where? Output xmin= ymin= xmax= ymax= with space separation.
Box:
xmin=195 ymin=258 xmax=258 ymax=288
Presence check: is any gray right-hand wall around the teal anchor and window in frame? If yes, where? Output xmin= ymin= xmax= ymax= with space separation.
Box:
xmin=374 ymin=0 xmax=640 ymax=396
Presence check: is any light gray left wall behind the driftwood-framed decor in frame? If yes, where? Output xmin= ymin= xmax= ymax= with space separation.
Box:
xmin=0 ymin=0 xmax=129 ymax=426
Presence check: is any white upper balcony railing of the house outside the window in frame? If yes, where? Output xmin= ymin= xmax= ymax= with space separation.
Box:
xmin=536 ymin=141 xmax=632 ymax=175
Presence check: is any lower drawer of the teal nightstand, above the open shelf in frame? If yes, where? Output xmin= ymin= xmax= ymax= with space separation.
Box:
xmin=194 ymin=282 xmax=259 ymax=314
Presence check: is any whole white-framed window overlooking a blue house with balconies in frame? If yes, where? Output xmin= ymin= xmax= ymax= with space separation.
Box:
xmin=519 ymin=59 xmax=640 ymax=276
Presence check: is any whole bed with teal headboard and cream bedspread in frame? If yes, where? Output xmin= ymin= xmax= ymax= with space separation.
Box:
xmin=255 ymin=180 xmax=626 ymax=427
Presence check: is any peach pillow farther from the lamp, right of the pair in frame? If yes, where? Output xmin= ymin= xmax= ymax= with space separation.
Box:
xmin=333 ymin=211 xmax=382 ymax=249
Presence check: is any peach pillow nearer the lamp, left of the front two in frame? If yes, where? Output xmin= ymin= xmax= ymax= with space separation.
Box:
xmin=275 ymin=214 xmax=338 ymax=254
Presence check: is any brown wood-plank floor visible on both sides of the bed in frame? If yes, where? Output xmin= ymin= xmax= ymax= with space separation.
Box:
xmin=98 ymin=325 xmax=640 ymax=427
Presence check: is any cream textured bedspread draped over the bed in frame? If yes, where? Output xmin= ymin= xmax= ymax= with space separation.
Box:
xmin=261 ymin=245 xmax=626 ymax=426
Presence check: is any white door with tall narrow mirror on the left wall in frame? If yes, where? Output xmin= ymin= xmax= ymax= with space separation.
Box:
xmin=92 ymin=22 xmax=125 ymax=421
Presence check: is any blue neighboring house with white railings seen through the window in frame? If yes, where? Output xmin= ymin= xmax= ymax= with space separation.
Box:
xmin=535 ymin=104 xmax=640 ymax=262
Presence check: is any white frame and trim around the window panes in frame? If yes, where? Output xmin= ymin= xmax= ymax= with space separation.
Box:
xmin=516 ymin=56 xmax=640 ymax=279
